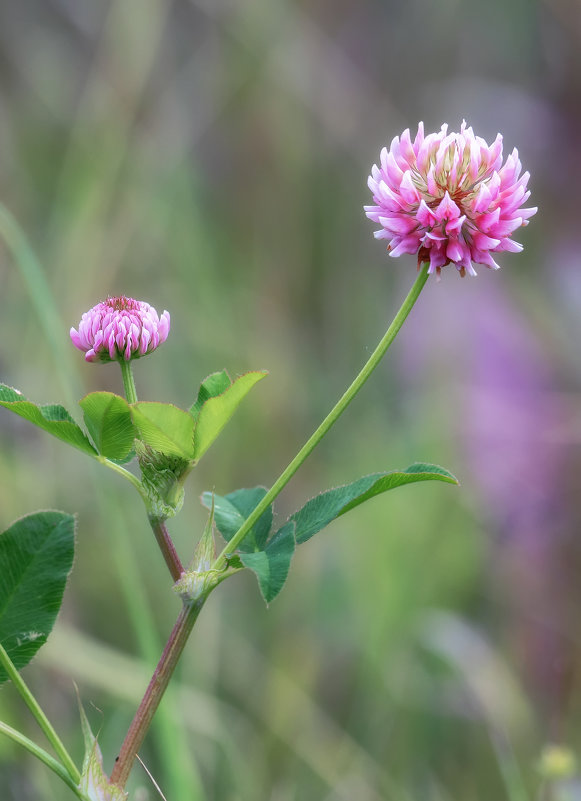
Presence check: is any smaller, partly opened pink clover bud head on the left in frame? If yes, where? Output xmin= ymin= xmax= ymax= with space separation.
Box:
xmin=71 ymin=295 xmax=170 ymax=362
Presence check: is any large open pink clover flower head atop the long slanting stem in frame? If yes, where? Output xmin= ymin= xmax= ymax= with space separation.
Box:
xmin=364 ymin=122 xmax=537 ymax=276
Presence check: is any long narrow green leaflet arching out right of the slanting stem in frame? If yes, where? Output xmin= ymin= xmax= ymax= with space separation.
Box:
xmin=290 ymin=463 xmax=458 ymax=544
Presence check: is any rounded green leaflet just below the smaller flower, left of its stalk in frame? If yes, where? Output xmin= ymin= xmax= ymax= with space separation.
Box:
xmin=79 ymin=392 xmax=137 ymax=461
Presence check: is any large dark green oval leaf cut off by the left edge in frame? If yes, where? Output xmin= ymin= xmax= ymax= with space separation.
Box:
xmin=0 ymin=512 xmax=75 ymax=682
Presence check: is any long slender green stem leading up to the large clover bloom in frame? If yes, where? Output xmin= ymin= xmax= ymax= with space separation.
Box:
xmin=212 ymin=264 xmax=428 ymax=570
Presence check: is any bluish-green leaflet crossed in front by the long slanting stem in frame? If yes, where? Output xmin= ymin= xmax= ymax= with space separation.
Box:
xmin=202 ymin=487 xmax=272 ymax=552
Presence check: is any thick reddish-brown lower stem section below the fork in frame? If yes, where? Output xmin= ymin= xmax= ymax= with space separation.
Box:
xmin=110 ymin=596 xmax=206 ymax=789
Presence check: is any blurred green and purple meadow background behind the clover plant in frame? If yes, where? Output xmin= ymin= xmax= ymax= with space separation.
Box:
xmin=0 ymin=0 xmax=581 ymax=801
